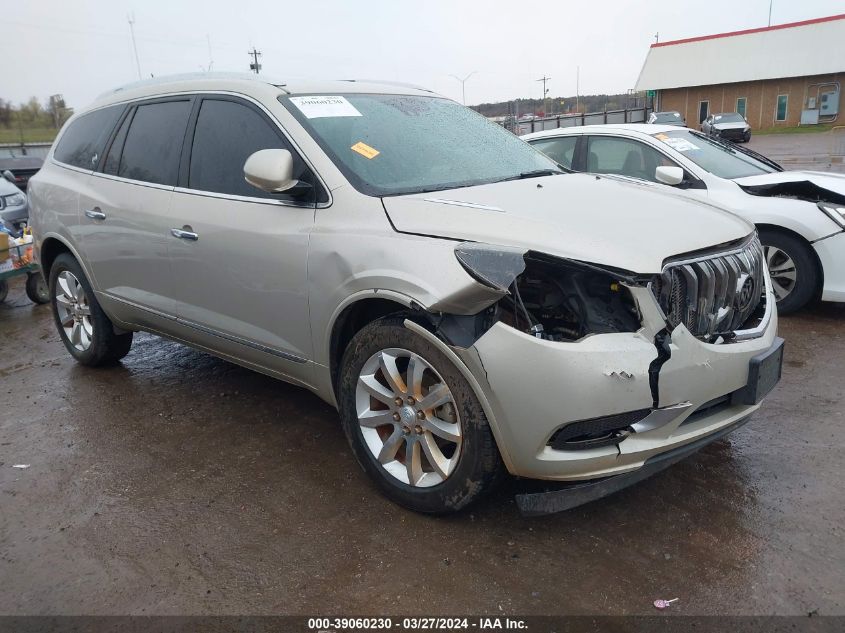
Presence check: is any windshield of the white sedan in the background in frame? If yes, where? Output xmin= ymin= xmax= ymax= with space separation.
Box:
xmin=652 ymin=130 xmax=776 ymax=179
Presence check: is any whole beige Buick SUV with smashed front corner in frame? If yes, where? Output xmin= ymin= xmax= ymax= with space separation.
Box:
xmin=29 ymin=74 xmax=782 ymax=514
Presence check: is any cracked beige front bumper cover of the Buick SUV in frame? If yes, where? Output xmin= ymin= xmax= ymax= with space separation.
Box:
xmin=456 ymin=288 xmax=777 ymax=481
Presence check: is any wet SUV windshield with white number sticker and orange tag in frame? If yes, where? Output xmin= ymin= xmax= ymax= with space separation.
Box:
xmin=279 ymin=94 xmax=562 ymax=196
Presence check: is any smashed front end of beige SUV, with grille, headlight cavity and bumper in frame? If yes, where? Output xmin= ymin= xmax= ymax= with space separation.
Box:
xmin=408 ymin=235 xmax=779 ymax=512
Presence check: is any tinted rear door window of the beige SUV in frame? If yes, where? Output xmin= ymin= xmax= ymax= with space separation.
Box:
xmin=115 ymin=101 xmax=191 ymax=185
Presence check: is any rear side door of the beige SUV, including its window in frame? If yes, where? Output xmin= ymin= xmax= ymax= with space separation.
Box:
xmin=79 ymin=97 xmax=193 ymax=329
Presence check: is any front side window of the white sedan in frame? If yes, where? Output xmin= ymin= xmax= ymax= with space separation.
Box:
xmin=587 ymin=136 xmax=679 ymax=182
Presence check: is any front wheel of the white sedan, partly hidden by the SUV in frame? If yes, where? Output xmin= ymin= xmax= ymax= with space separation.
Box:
xmin=760 ymin=229 xmax=819 ymax=314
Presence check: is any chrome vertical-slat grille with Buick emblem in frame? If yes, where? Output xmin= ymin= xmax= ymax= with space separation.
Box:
xmin=652 ymin=234 xmax=765 ymax=341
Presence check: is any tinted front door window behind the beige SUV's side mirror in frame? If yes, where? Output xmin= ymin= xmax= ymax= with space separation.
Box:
xmin=188 ymin=99 xmax=314 ymax=200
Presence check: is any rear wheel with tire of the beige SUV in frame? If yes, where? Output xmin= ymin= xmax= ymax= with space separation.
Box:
xmin=50 ymin=253 xmax=132 ymax=367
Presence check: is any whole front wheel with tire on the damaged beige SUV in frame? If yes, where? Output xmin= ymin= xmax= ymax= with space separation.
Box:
xmin=339 ymin=318 xmax=503 ymax=514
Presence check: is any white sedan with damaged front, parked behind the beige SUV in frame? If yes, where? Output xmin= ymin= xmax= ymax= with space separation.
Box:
xmin=523 ymin=124 xmax=845 ymax=314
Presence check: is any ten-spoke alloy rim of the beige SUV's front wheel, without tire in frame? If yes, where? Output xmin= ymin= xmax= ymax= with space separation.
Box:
xmin=355 ymin=348 xmax=463 ymax=487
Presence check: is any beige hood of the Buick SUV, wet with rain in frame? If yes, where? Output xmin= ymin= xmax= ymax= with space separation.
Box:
xmin=383 ymin=174 xmax=753 ymax=274
